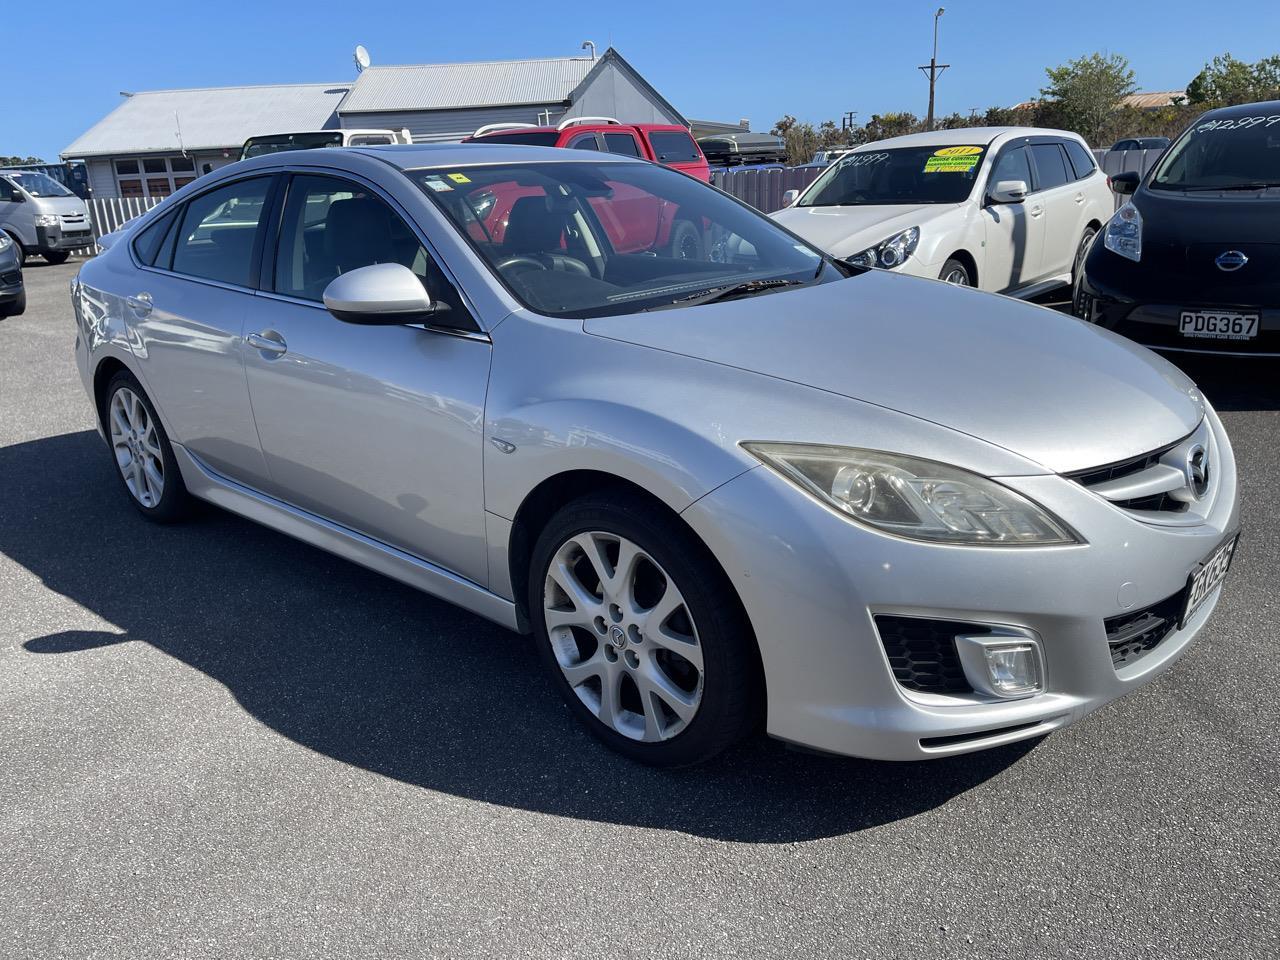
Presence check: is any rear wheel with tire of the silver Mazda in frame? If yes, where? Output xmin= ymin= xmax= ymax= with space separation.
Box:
xmin=102 ymin=370 xmax=191 ymax=524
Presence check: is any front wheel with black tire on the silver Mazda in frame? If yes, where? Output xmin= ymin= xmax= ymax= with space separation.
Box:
xmin=529 ymin=493 xmax=763 ymax=767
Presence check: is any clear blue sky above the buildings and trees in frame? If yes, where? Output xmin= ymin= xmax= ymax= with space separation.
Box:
xmin=10 ymin=0 xmax=1280 ymax=160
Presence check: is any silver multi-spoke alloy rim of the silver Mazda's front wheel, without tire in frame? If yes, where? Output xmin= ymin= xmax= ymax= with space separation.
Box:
xmin=543 ymin=531 xmax=703 ymax=742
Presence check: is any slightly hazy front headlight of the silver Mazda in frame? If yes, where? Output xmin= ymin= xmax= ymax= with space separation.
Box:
xmin=742 ymin=443 xmax=1084 ymax=547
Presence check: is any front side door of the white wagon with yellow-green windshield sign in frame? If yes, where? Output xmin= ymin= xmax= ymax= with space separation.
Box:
xmin=978 ymin=143 xmax=1044 ymax=293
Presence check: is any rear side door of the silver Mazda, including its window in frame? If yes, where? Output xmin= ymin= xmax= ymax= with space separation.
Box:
xmin=119 ymin=175 xmax=276 ymax=486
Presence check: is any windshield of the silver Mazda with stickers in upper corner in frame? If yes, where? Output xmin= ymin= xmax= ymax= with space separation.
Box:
xmin=408 ymin=161 xmax=844 ymax=317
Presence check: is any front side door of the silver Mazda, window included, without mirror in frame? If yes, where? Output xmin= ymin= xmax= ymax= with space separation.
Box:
xmin=243 ymin=173 xmax=490 ymax=584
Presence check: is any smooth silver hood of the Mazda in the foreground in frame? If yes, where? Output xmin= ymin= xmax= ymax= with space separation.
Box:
xmin=584 ymin=271 xmax=1204 ymax=472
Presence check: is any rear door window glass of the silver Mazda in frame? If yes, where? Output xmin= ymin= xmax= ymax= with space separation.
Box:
xmin=173 ymin=177 xmax=271 ymax=287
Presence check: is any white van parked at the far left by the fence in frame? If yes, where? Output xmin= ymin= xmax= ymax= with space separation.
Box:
xmin=0 ymin=170 xmax=93 ymax=264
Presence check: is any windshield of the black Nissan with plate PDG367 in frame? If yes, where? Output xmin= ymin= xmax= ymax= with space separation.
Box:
xmin=1148 ymin=115 xmax=1280 ymax=191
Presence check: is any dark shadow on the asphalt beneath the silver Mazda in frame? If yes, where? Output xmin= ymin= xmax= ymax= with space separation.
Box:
xmin=0 ymin=431 xmax=1033 ymax=842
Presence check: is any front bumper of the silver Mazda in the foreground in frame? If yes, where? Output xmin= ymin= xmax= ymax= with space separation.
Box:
xmin=684 ymin=412 xmax=1238 ymax=760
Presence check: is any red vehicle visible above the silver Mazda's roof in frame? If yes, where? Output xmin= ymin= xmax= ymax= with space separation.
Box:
xmin=462 ymin=116 xmax=712 ymax=183
